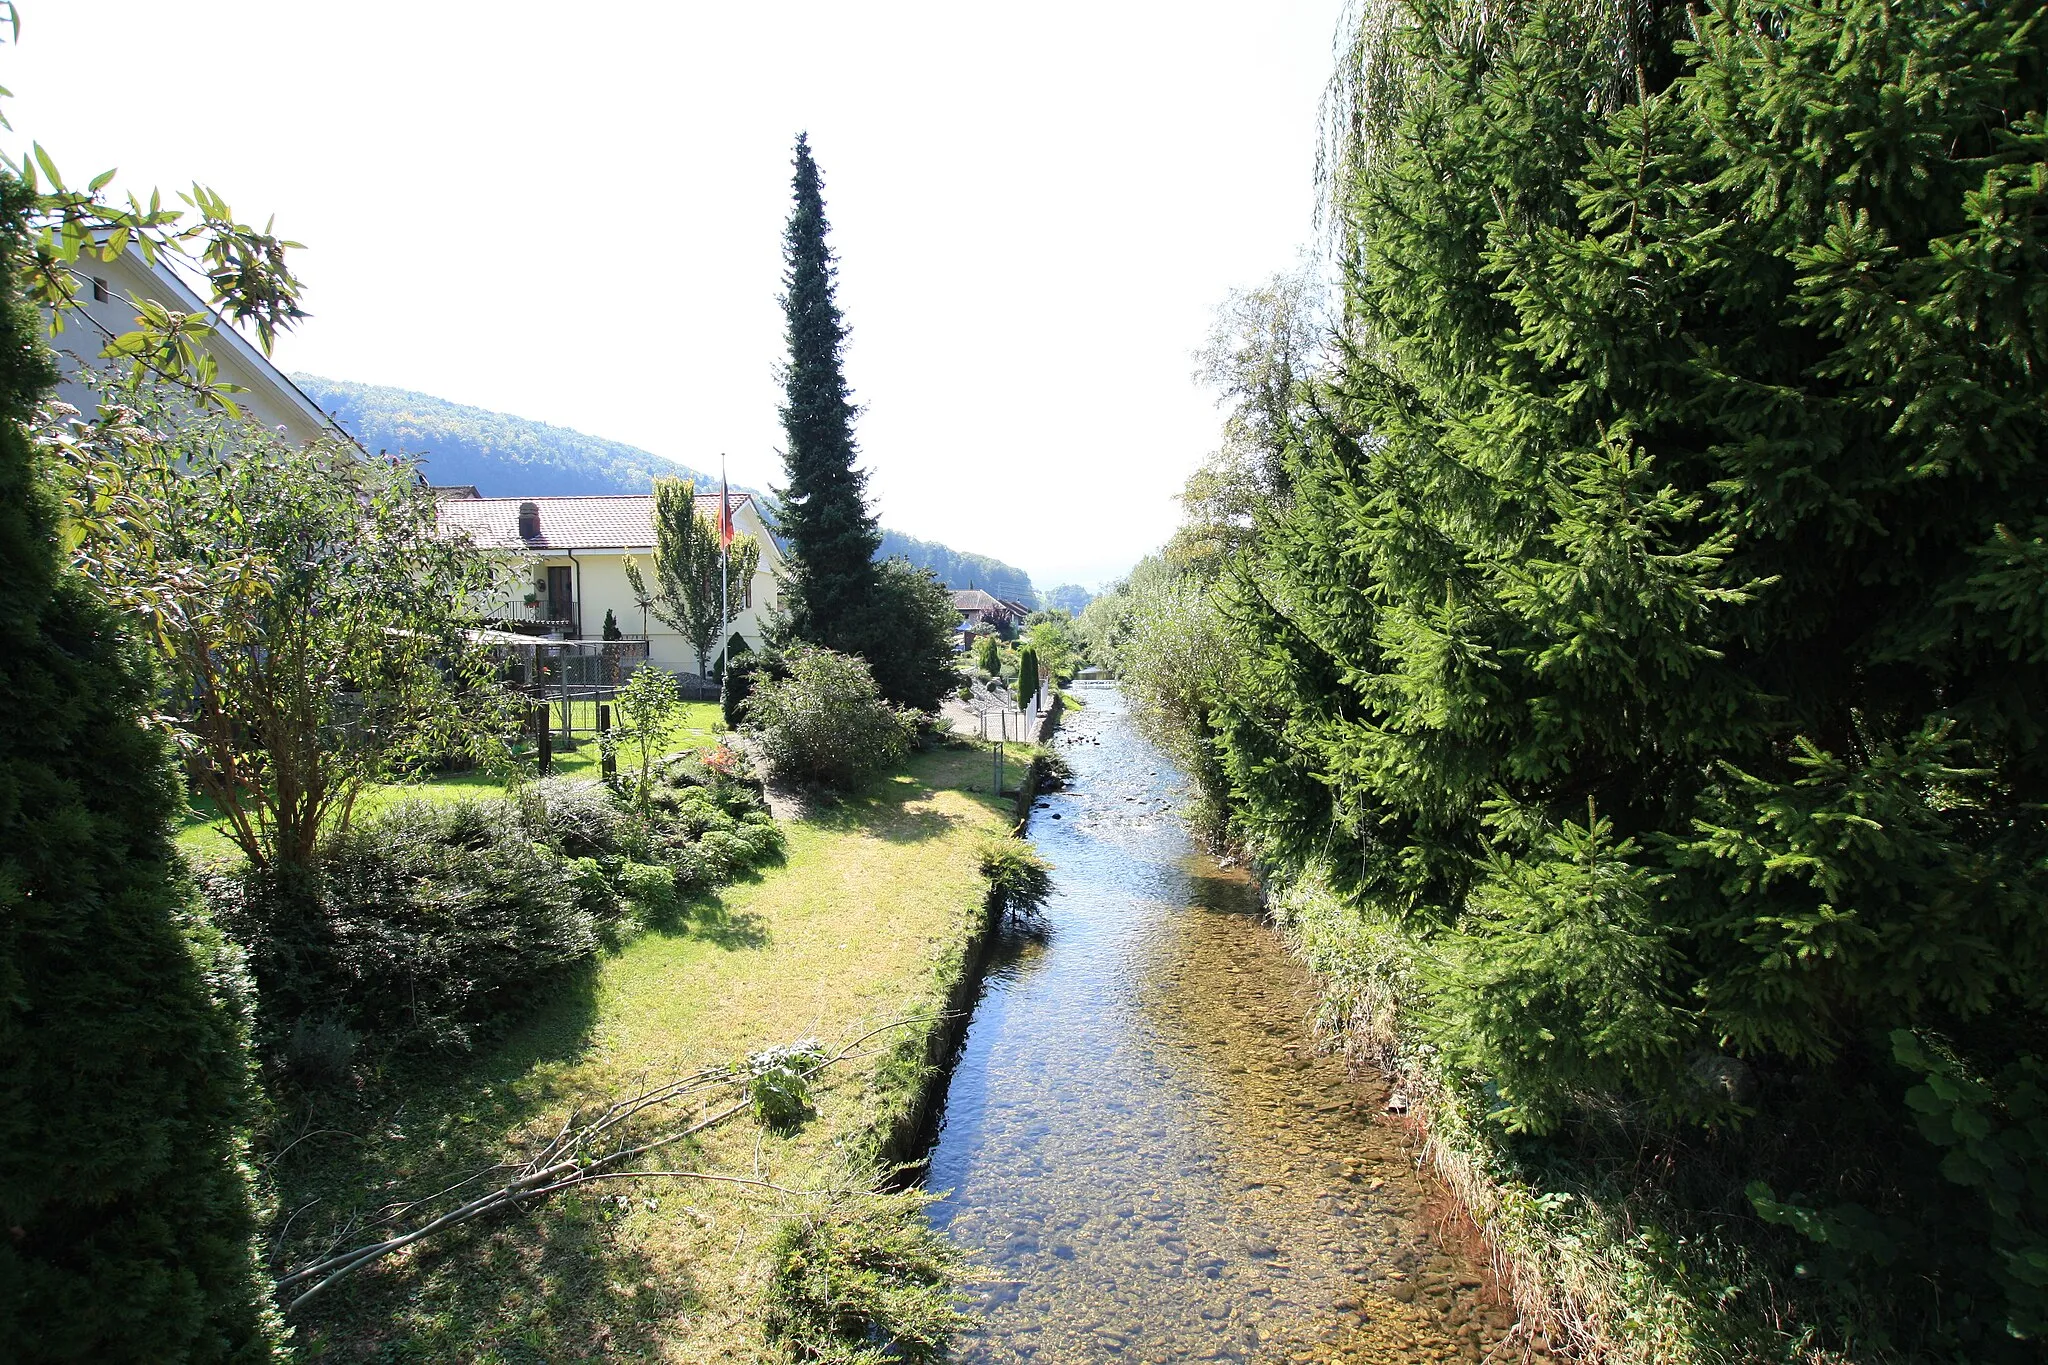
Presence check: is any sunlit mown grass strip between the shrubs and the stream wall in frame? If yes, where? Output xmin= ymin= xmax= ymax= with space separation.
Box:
xmin=266 ymin=747 xmax=1008 ymax=1363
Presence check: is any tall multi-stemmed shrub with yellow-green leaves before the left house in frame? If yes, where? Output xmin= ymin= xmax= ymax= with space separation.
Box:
xmin=37 ymin=389 xmax=518 ymax=866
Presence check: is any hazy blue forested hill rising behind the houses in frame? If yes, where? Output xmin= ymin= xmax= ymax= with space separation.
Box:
xmin=291 ymin=375 xmax=1038 ymax=604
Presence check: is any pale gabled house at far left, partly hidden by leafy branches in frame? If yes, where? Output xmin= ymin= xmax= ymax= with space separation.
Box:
xmin=49 ymin=248 xmax=346 ymax=444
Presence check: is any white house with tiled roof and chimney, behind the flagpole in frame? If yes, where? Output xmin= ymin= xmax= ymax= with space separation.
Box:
xmin=434 ymin=497 xmax=782 ymax=673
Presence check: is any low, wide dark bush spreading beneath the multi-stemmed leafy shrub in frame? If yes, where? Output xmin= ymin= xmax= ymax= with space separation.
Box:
xmin=209 ymin=798 xmax=621 ymax=1046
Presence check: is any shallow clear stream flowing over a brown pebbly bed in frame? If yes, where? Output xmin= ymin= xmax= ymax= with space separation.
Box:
xmin=930 ymin=686 xmax=1524 ymax=1363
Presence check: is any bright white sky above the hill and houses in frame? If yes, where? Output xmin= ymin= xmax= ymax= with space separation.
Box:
xmin=0 ymin=0 xmax=1341 ymax=587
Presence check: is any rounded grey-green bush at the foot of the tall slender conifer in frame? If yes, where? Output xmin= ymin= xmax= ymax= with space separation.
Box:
xmin=748 ymin=645 xmax=918 ymax=788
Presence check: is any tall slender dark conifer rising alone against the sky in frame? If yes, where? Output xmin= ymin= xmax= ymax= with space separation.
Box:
xmin=778 ymin=133 xmax=883 ymax=651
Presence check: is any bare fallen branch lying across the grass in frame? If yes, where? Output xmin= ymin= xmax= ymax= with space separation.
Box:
xmin=276 ymin=1015 xmax=938 ymax=1312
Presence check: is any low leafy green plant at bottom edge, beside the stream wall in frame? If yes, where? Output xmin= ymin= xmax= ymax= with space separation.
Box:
xmin=762 ymin=1189 xmax=967 ymax=1365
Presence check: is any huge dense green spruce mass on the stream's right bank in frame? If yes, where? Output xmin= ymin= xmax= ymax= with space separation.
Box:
xmin=1214 ymin=0 xmax=2048 ymax=1359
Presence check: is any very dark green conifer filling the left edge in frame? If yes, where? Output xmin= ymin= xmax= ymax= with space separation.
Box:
xmin=0 ymin=178 xmax=276 ymax=1361
